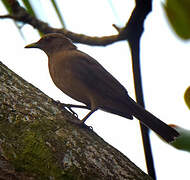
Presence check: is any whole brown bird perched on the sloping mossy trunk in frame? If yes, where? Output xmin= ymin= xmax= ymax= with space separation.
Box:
xmin=25 ymin=33 xmax=179 ymax=142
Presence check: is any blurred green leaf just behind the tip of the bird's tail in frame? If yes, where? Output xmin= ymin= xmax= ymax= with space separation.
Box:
xmin=170 ymin=125 xmax=190 ymax=152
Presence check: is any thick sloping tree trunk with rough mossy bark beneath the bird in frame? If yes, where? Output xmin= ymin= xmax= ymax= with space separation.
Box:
xmin=0 ymin=63 xmax=151 ymax=180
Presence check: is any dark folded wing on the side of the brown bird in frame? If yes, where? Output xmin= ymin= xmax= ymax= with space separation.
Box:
xmin=67 ymin=50 xmax=128 ymax=102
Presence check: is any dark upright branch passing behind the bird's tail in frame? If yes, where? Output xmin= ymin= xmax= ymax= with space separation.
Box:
xmin=126 ymin=0 xmax=156 ymax=180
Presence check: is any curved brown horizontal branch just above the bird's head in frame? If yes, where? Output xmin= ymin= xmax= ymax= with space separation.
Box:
xmin=0 ymin=1 xmax=124 ymax=46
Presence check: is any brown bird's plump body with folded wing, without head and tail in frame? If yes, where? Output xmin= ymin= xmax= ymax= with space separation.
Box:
xmin=49 ymin=50 xmax=132 ymax=119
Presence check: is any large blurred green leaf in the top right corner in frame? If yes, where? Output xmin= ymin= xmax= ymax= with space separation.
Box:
xmin=163 ymin=0 xmax=190 ymax=40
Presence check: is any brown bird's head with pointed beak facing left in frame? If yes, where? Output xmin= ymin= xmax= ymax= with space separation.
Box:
xmin=25 ymin=33 xmax=76 ymax=56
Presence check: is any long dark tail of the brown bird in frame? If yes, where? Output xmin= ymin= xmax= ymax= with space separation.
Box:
xmin=131 ymin=99 xmax=180 ymax=143
